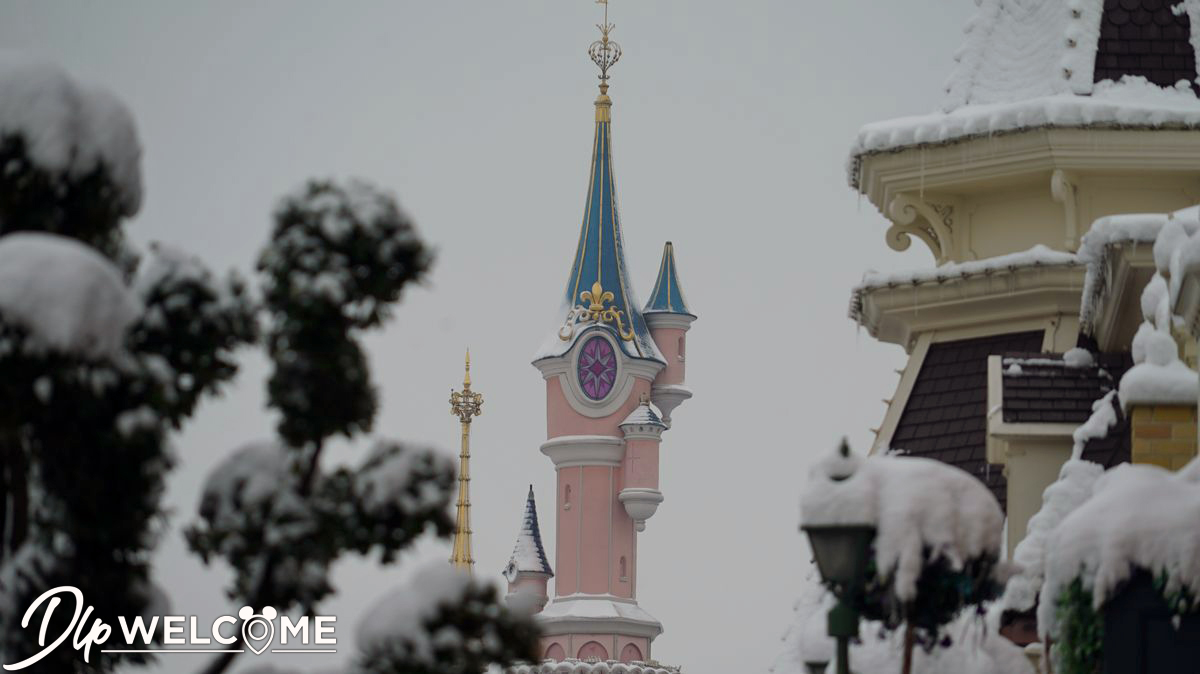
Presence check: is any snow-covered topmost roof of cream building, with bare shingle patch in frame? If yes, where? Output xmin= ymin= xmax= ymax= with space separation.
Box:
xmin=847 ymin=0 xmax=1200 ymax=188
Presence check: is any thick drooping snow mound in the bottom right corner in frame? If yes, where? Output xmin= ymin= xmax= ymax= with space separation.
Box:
xmin=1038 ymin=459 xmax=1200 ymax=637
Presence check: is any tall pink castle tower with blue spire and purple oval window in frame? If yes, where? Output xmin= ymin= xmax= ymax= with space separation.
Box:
xmin=510 ymin=13 xmax=696 ymax=662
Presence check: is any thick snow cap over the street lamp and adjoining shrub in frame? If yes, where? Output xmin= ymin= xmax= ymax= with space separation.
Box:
xmin=800 ymin=452 xmax=1004 ymax=601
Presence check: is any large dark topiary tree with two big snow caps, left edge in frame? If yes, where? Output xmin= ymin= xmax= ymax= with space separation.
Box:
xmin=0 ymin=53 xmax=254 ymax=672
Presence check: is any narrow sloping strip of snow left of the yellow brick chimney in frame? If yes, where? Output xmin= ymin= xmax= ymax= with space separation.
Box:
xmin=1000 ymin=453 xmax=1111 ymax=612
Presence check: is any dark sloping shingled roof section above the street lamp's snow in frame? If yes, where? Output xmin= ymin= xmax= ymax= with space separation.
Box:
xmin=892 ymin=331 xmax=1042 ymax=507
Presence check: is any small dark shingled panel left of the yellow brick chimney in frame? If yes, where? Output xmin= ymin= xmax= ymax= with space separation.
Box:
xmin=1001 ymin=354 xmax=1114 ymax=423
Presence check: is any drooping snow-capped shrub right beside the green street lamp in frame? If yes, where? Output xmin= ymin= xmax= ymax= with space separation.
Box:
xmin=800 ymin=444 xmax=1007 ymax=648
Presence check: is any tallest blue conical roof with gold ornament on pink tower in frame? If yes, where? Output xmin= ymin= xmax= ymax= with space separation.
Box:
xmin=539 ymin=94 xmax=666 ymax=362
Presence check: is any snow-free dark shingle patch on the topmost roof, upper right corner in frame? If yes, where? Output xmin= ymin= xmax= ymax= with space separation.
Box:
xmin=1093 ymin=0 xmax=1200 ymax=94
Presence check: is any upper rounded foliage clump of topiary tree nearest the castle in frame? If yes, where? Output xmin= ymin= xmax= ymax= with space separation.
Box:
xmin=258 ymin=181 xmax=432 ymax=446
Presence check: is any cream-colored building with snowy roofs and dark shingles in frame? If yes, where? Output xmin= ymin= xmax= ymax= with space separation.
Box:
xmin=848 ymin=0 xmax=1200 ymax=550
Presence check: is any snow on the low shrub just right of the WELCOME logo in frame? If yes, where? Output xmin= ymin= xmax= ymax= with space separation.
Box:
xmin=355 ymin=561 xmax=472 ymax=667
